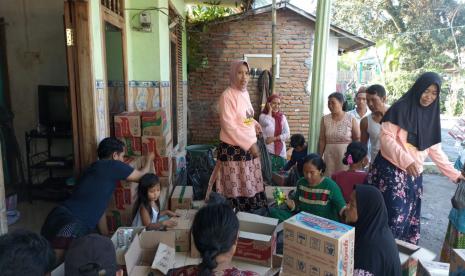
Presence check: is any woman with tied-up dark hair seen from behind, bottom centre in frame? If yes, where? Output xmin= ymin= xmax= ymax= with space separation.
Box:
xmin=167 ymin=193 xmax=258 ymax=276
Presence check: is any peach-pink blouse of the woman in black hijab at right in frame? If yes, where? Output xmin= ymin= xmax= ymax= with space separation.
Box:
xmin=379 ymin=122 xmax=460 ymax=181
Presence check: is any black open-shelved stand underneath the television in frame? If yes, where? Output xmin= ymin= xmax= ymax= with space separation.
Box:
xmin=25 ymin=130 xmax=74 ymax=201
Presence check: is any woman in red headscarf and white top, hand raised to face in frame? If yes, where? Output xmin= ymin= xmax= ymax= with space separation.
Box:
xmin=259 ymin=94 xmax=290 ymax=172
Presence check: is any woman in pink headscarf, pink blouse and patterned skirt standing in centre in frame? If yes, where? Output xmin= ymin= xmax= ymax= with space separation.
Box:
xmin=210 ymin=61 xmax=266 ymax=211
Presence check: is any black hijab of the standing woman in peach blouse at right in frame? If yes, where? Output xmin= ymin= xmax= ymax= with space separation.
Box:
xmin=381 ymin=72 xmax=441 ymax=150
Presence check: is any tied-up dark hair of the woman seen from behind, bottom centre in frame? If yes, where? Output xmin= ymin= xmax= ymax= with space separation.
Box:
xmin=191 ymin=195 xmax=239 ymax=276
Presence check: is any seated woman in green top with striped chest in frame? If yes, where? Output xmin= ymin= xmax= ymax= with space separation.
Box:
xmin=270 ymin=154 xmax=346 ymax=221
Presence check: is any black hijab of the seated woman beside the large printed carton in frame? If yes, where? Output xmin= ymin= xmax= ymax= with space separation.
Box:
xmin=354 ymin=185 xmax=402 ymax=276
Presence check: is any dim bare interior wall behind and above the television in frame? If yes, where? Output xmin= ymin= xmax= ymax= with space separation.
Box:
xmin=0 ymin=0 xmax=68 ymax=166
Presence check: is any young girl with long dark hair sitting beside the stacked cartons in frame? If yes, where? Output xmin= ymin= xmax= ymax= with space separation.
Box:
xmin=132 ymin=173 xmax=177 ymax=230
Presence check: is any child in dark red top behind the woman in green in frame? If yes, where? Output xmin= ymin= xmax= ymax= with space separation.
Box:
xmin=331 ymin=142 xmax=368 ymax=202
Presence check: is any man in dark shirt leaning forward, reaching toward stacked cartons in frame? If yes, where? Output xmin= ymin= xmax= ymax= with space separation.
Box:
xmin=41 ymin=137 xmax=154 ymax=263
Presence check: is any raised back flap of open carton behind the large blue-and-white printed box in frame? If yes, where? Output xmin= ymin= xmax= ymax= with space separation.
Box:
xmin=237 ymin=212 xmax=279 ymax=235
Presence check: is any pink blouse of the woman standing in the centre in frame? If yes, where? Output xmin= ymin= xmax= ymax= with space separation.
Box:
xmin=219 ymin=87 xmax=258 ymax=151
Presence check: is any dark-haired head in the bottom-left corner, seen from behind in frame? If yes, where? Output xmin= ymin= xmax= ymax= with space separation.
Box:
xmin=0 ymin=230 xmax=55 ymax=276
